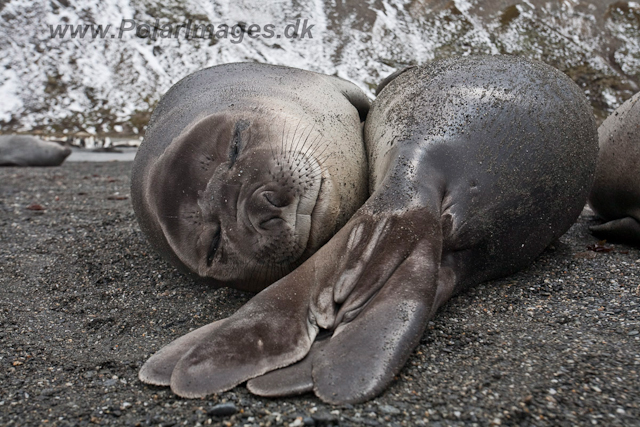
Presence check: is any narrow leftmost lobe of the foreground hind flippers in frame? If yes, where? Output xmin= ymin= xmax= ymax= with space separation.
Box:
xmin=138 ymin=319 xmax=225 ymax=386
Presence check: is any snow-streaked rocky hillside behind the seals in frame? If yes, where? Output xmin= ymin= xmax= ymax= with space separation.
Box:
xmin=0 ymin=0 xmax=640 ymax=134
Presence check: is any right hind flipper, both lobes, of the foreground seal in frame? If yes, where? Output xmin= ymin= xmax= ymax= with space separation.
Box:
xmin=247 ymin=214 xmax=455 ymax=404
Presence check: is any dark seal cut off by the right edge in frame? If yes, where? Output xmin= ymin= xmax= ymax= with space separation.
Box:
xmin=589 ymin=92 xmax=640 ymax=246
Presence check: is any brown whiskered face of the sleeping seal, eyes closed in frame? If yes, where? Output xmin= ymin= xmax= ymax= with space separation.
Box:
xmin=138 ymin=111 xmax=352 ymax=291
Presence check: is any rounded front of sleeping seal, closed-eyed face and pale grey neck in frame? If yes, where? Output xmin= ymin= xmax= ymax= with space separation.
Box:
xmin=131 ymin=63 xmax=369 ymax=292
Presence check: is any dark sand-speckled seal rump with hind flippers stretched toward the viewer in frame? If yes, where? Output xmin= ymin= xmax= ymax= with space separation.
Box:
xmin=142 ymin=56 xmax=598 ymax=404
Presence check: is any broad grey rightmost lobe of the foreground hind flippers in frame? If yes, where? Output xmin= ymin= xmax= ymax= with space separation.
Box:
xmin=313 ymin=241 xmax=440 ymax=404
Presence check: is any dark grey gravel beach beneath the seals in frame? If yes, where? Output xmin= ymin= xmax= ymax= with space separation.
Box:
xmin=0 ymin=162 xmax=640 ymax=426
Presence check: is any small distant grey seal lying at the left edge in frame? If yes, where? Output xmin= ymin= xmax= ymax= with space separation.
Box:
xmin=0 ymin=135 xmax=71 ymax=166
